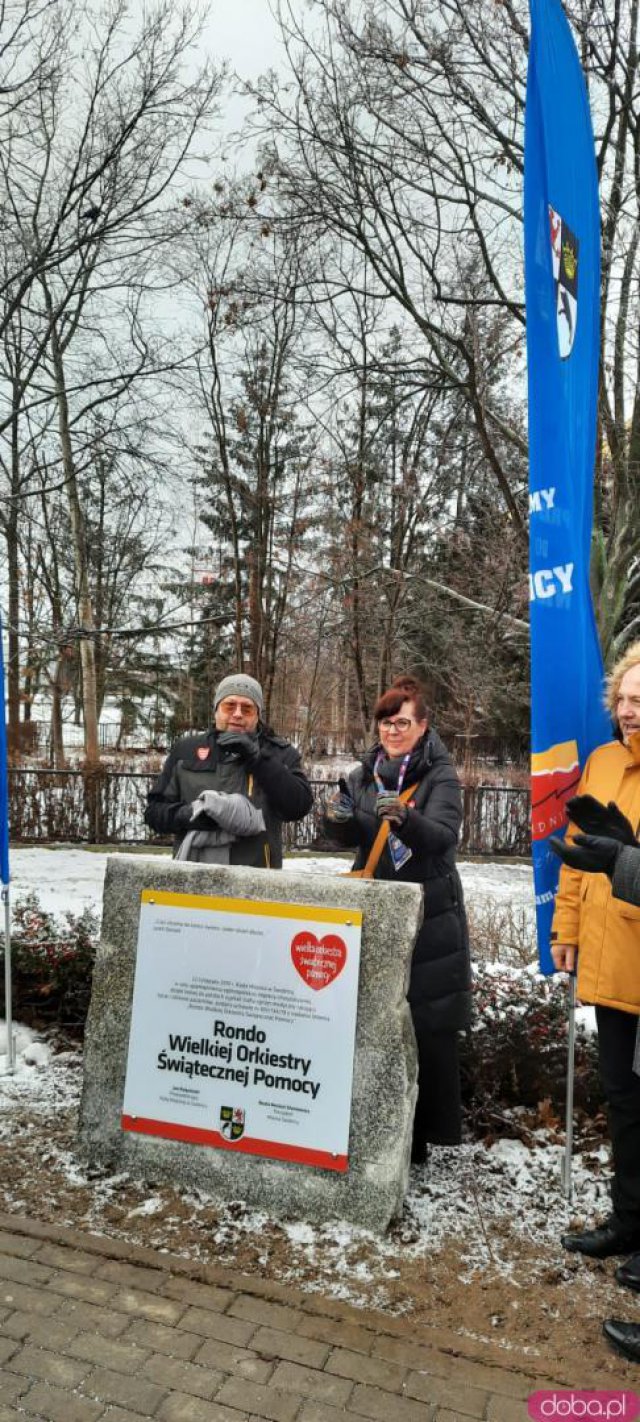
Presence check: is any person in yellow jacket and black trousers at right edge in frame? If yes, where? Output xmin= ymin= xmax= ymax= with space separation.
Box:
xmin=552 ymin=641 xmax=640 ymax=1262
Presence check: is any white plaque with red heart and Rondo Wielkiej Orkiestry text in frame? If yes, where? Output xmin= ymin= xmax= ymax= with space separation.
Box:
xmin=121 ymin=889 xmax=363 ymax=1170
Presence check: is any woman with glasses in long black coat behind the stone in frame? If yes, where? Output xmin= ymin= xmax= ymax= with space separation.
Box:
xmin=326 ymin=674 xmax=471 ymax=1162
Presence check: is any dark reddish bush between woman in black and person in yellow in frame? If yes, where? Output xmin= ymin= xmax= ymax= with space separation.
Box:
xmin=462 ymin=963 xmax=603 ymax=1135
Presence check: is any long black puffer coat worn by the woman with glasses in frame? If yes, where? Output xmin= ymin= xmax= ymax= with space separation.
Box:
xmin=326 ymin=731 xmax=471 ymax=1034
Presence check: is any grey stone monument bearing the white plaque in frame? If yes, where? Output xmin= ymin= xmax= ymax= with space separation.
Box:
xmin=80 ymin=855 xmax=422 ymax=1230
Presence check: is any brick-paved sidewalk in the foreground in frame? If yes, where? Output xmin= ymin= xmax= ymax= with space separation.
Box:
xmin=0 ymin=1214 xmax=623 ymax=1422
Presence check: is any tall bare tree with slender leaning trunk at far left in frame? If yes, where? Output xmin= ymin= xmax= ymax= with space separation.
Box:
xmin=0 ymin=0 xmax=220 ymax=766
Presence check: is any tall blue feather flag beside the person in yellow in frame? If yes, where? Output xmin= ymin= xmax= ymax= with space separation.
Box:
xmin=525 ymin=0 xmax=612 ymax=973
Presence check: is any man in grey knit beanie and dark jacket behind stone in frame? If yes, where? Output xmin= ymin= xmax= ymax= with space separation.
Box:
xmin=145 ymin=671 xmax=313 ymax=869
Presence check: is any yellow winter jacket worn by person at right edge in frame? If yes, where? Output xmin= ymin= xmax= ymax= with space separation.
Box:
xmin=552 ymin=731 xmax=640 ymax=1014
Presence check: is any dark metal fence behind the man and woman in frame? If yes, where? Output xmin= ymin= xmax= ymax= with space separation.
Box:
xmin=9 ymin=768 xmax=530 ymax=856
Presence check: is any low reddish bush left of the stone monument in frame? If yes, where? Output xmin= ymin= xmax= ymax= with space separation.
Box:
xmin=0 ymin=893 xmax=98 ymax=1037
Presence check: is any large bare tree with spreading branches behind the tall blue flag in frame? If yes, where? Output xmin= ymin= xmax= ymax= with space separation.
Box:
xmin=244 ymin=0 xmax=640 ymax=656
